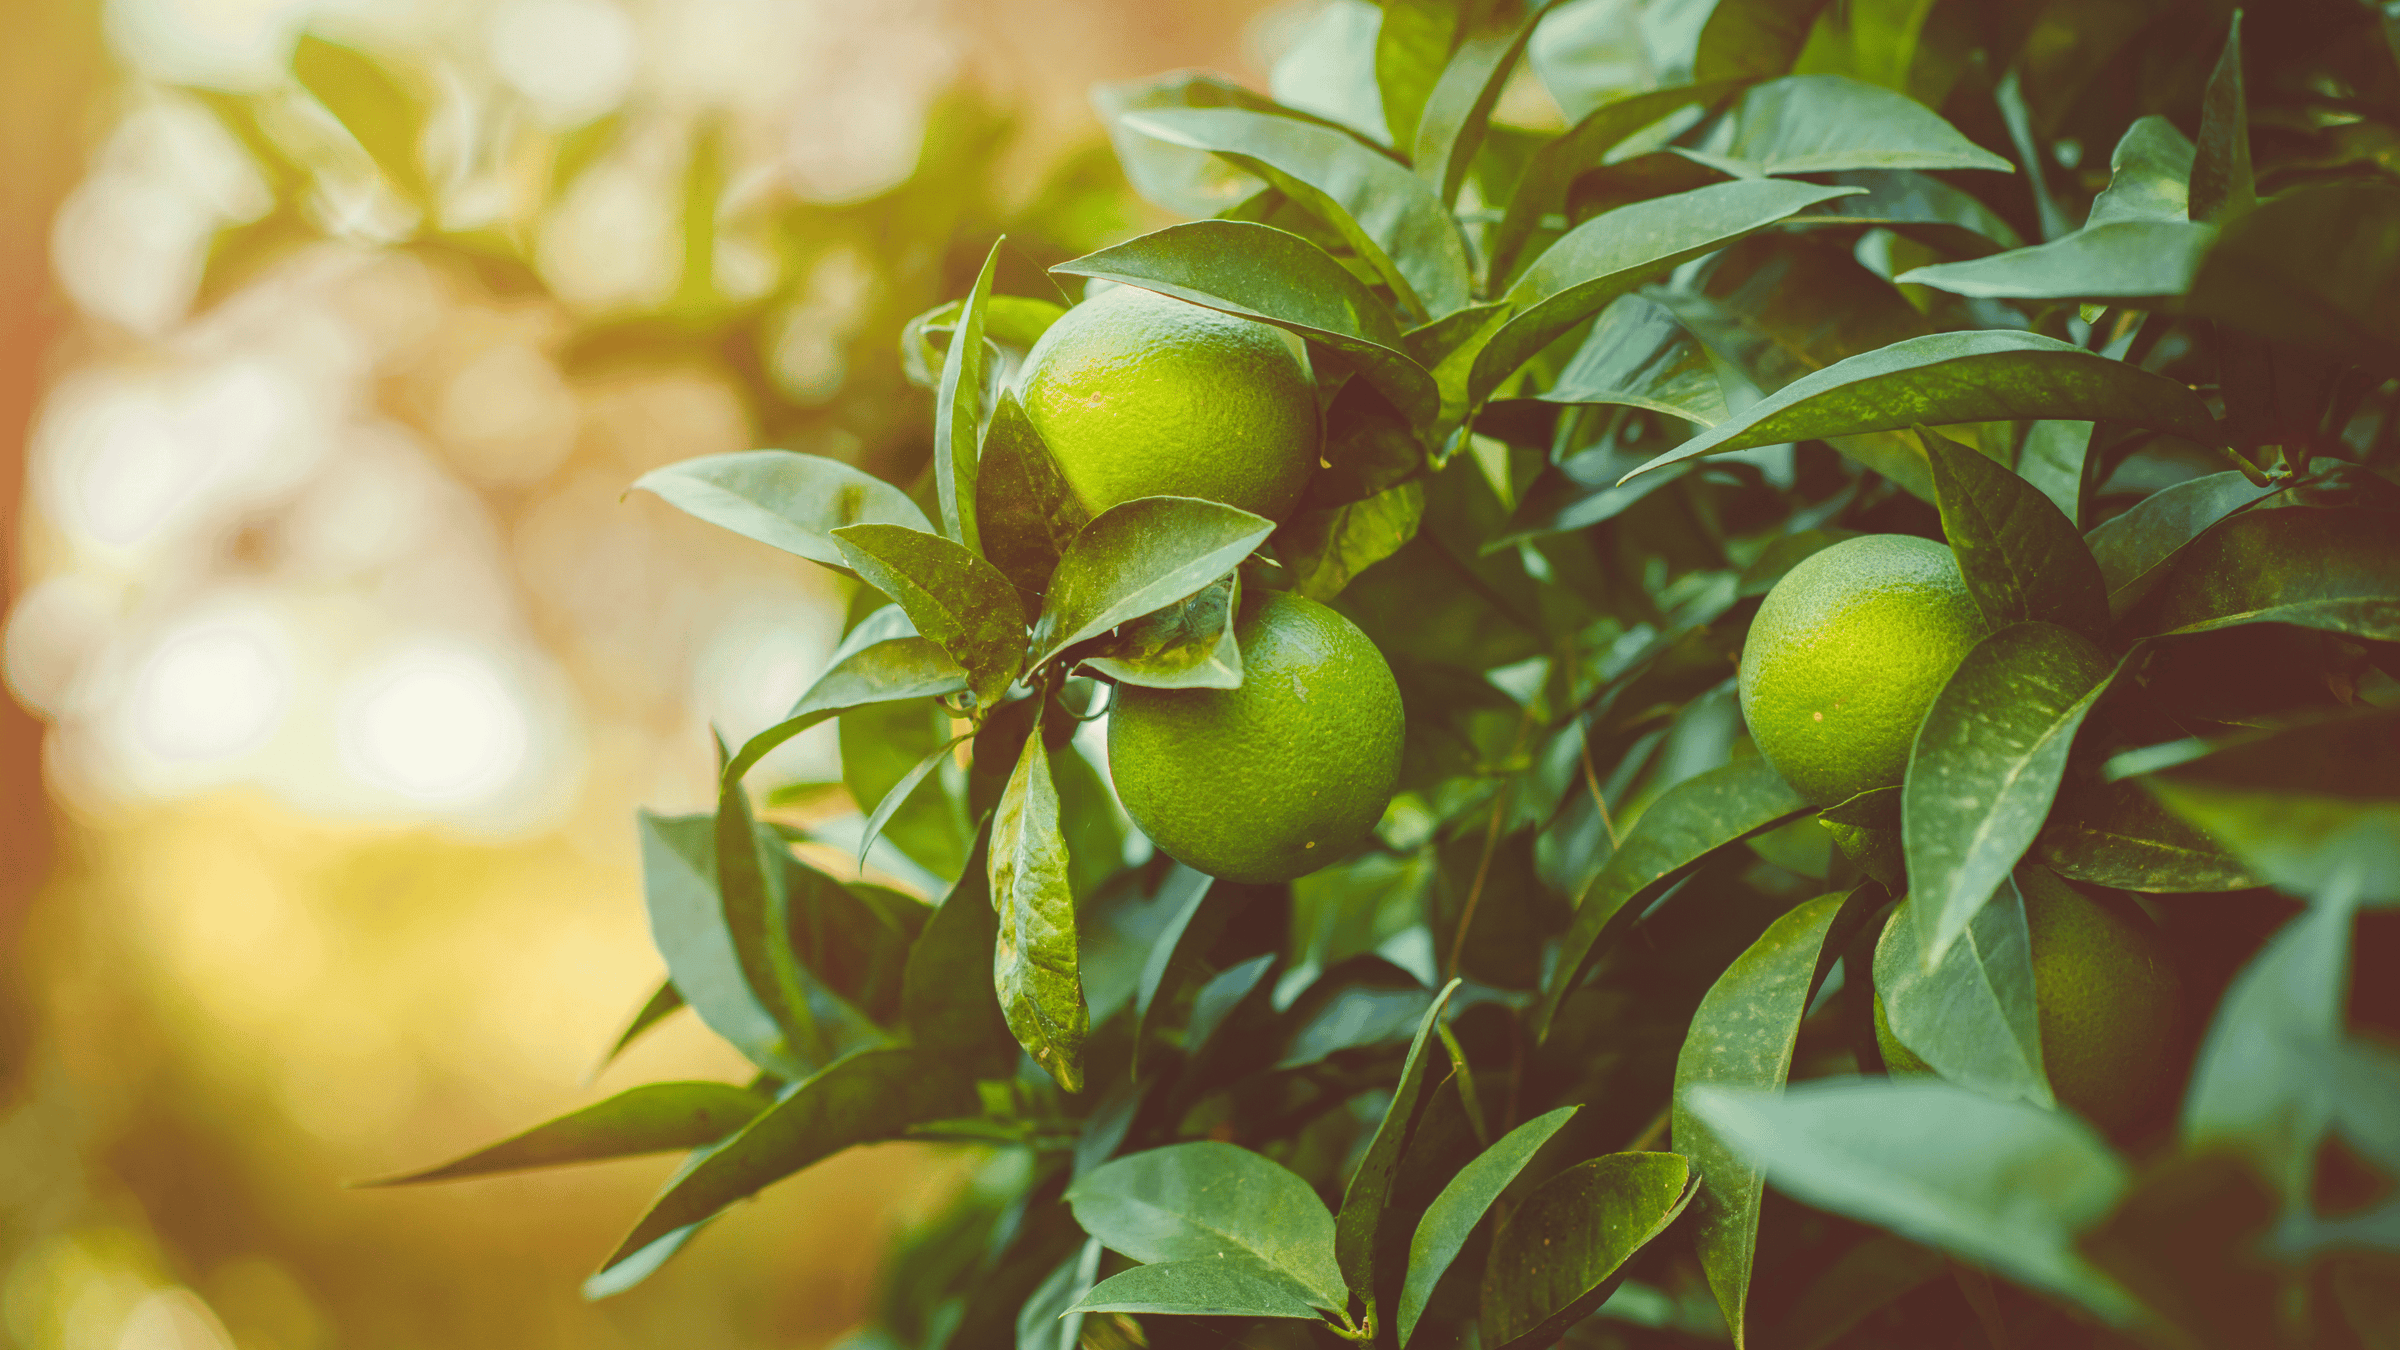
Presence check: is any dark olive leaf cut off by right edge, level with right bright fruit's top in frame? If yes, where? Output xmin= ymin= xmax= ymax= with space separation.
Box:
xmin=2124 ymin=504 xmax=2400 ymax=641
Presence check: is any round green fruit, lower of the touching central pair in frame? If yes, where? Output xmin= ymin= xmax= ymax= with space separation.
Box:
xmin=1109 ymin=591 xmax=1404 ymax=882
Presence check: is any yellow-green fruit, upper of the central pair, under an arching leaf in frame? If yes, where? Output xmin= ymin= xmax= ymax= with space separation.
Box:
xmin=1018 ymin=286 xmax=1318 ymax=521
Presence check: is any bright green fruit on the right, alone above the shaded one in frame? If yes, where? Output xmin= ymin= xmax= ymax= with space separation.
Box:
xmin=1738 ymin=533 xmax=1985 ymax=807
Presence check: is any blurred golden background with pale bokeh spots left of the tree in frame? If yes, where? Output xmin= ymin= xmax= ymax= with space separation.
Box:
xmin=0 ymin=0 xmax=1401 ymax=1350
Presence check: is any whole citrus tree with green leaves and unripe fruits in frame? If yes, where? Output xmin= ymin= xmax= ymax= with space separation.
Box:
xmin=360 ymin=0 xmax=2400 ymax=1350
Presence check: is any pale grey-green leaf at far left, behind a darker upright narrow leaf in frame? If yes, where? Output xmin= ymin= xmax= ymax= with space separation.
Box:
xmin=641 ymin=812 xmax=804 ymax=1076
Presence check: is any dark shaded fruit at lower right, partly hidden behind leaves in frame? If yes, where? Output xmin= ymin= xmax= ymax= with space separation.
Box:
xmin=1874 ymin=867 xmax=2184 ymax=1131
